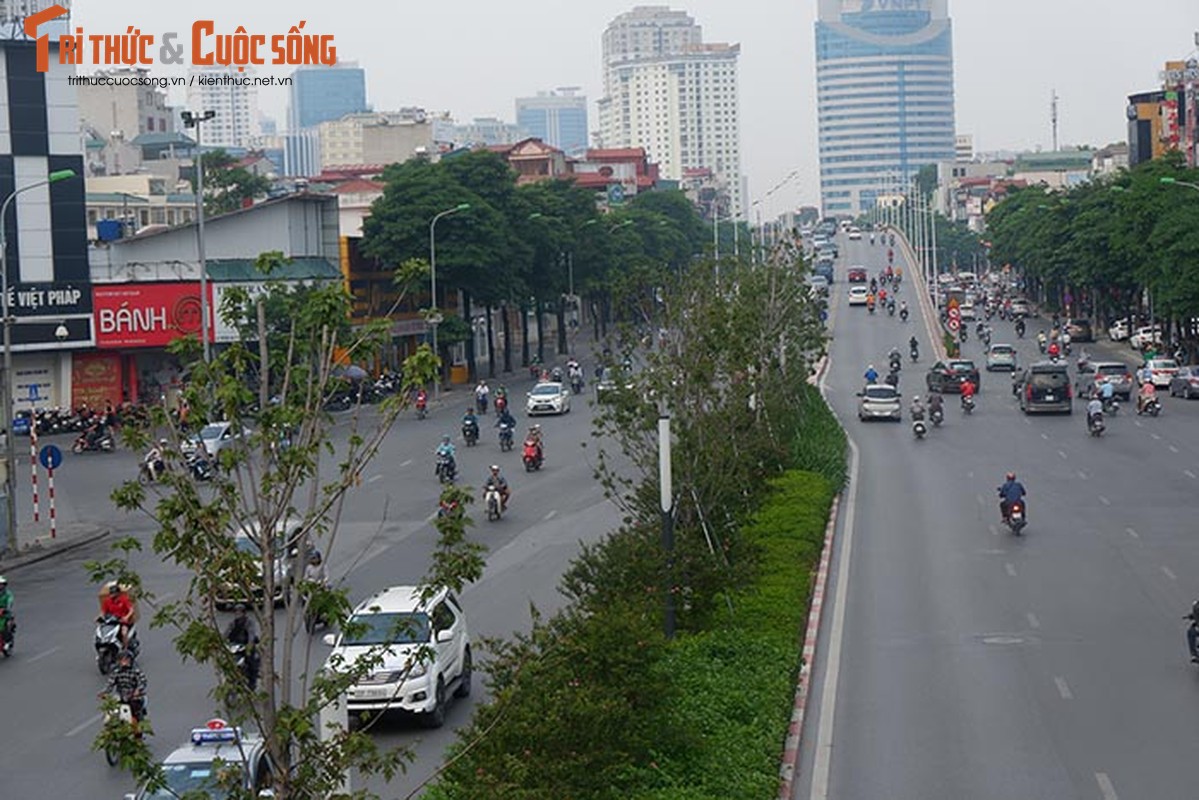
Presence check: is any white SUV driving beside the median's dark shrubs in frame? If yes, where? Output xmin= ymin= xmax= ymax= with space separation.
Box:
xmin=325 ymin=587 xmax=472 ymax=728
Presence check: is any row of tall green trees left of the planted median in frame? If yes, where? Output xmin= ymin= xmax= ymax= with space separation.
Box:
xmin=354 ymin=150 xmax=710 ymax=372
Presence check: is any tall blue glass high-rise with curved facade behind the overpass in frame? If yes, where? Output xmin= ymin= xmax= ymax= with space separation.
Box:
xmin=815 ymin=0 xmax=956 ymax=213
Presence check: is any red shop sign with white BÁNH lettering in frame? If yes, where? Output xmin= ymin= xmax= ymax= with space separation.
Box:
xmin=92 ymin=281 xmax=212 ymax=348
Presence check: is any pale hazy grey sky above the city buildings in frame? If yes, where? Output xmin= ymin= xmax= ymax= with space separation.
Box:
xmin=72 ymin=0 xmax=1199 ymax=215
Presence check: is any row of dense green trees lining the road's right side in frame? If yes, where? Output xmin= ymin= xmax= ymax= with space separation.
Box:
xmin=987 ymin=155 xmax=1199 ymax=341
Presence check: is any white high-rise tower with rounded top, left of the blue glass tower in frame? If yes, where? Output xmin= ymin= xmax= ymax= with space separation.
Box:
xmin=597 ymin=6 xmax=745 ymax=216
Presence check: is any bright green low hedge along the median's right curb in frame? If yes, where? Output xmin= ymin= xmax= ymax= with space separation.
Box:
xmin=633 ymin=471 xmax=833 ymax=800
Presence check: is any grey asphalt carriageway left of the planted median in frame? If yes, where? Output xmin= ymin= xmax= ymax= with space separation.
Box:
xmin=0 ymin=363 xmax=620 ymax=798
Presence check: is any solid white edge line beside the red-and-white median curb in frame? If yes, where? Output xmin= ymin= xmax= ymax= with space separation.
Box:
xmin=811 ymin=441 xmax=860 ymax=800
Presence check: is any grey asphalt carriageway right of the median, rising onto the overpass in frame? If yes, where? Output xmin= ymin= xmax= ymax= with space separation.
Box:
xmin=795 ymin=235 xmax=1199 ymax=800
